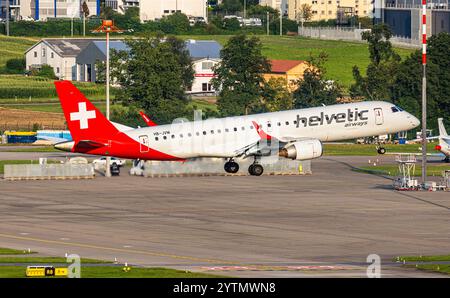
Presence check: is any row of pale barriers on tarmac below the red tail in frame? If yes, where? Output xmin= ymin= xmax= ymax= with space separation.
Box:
xmin=3 ymin=164 xmax=94 ymax=180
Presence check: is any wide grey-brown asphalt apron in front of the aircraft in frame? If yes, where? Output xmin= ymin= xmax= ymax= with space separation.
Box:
xmin=0 ymin=153 xmax=450 ymax=277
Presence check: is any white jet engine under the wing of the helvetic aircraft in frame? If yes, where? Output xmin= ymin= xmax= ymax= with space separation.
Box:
xmin=279 ymin=139 xmax=323 ymax=160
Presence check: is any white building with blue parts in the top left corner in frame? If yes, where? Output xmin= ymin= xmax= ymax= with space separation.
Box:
xmin=0 ymin=0 xmax=100 ymax=21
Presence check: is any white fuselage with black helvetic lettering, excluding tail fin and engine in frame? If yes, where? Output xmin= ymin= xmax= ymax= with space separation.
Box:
xmin=109 ymin=101 xmax=419 ymax=160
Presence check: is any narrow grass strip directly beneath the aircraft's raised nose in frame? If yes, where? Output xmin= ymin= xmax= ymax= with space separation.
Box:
xmin=323 ymin=143 xmax=436 ymax=156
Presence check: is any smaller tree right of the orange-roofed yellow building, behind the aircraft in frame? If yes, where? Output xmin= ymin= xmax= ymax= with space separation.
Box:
xmin=294 ymin=52 xmax=342 ymax=109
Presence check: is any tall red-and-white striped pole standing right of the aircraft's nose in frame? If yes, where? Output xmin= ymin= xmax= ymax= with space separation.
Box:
xmin=422 ymin=0 xmax=427 ymax=185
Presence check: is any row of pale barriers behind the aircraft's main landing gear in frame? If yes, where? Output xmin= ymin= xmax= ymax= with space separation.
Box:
xmin=130 ymin=158 xmax=312 ymax=177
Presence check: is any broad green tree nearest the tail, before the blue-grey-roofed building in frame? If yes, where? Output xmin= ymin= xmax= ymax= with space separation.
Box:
xmin=116 ymin=35 xmax=193 ymax=123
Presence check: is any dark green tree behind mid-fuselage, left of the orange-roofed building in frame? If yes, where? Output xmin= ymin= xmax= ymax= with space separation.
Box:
xmin=212 ymin=34 xmax=270 ymax=116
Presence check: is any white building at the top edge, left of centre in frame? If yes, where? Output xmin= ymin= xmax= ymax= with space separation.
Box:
xmin=140 ymin=0 xmax=208 ymax=22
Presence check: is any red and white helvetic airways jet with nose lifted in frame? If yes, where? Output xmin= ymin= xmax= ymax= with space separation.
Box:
xmin=55 ymin=81 xmax=420 ymax=176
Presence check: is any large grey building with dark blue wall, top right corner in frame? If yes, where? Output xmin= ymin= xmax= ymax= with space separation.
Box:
xmin=375 ymin=0 xmax=450 ymax=40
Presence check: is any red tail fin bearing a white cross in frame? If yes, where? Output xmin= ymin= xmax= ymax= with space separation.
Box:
xmin=55 ymin=81 xmax=118 ymax=142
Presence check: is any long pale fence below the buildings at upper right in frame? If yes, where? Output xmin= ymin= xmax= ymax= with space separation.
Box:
xmin=298 ymin=26 xmax=422 ymax=48
